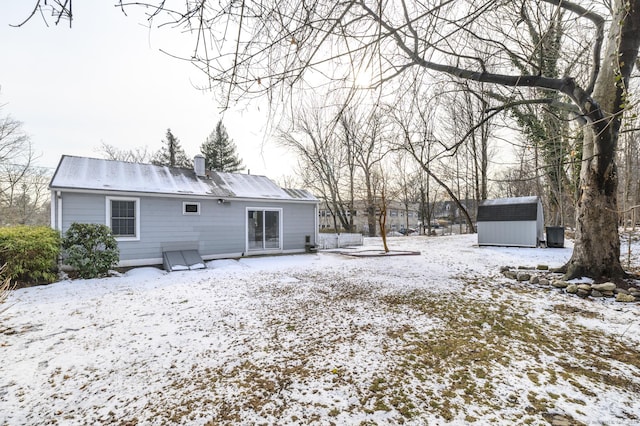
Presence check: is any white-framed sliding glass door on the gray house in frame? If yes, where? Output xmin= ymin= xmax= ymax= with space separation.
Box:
xmin=247 ymin=208 xmax=282 ymax=250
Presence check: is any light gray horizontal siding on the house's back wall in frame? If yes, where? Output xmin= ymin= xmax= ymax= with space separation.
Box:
xmin=56 ymin=192 xmax=315 ymax=261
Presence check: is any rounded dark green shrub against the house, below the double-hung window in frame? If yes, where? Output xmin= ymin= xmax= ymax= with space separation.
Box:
xmin=62 ymin=223 xmax=120 ymax=278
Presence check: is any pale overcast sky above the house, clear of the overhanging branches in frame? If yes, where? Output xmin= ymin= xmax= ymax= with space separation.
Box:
xmin=0 ymin=0 xmax=293 ymax=179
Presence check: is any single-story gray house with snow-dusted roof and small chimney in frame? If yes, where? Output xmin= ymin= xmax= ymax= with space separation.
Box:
xmin=50 ymin=155 xmax=318 ymax=266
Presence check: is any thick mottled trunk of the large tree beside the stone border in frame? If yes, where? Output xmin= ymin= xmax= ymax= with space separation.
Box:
xmin=565 ymin=0 xmax=640 ymax=279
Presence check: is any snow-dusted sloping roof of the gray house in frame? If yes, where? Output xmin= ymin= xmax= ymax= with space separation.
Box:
xmin=49 ymin=155 xmax=317 ymax=201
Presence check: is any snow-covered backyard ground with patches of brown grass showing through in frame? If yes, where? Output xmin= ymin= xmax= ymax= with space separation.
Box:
xmin=0 ymin=235 xmax=640 ymax=425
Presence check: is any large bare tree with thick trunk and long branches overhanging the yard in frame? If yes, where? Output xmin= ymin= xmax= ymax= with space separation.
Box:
xmin=22 ymin=0 xmax=640 ymax=278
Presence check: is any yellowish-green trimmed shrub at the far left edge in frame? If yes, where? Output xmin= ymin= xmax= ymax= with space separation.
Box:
xmin=0 ymin=226 xmax=60 ymax=284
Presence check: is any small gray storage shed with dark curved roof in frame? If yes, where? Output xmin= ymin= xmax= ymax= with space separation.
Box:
xmin=478 ymin=197 xmax=544 ymax=247
